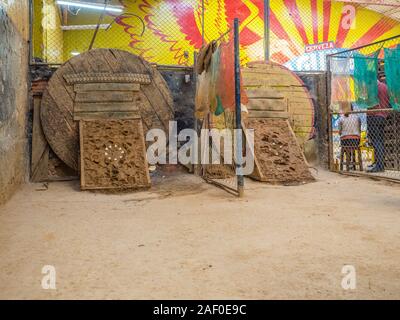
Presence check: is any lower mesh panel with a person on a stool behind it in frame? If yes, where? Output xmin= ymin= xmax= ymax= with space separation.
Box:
xmin=332 ymin=110 xmax=400 ymax=180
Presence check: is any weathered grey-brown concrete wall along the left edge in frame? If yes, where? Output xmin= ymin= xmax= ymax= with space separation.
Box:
xmin=0 ymin=0 xmax=29 ymax=204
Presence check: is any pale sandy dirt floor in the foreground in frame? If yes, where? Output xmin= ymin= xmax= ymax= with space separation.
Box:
xmin=0 ymin=168 xmax=400 ymax=299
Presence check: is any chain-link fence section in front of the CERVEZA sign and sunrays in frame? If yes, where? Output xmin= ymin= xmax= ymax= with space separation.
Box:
xmin=270 ymin=0 xmax=400 ymax=71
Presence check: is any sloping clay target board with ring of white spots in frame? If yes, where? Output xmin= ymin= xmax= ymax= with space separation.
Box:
xmin=79 ymin=119 xmax=151 ymax=190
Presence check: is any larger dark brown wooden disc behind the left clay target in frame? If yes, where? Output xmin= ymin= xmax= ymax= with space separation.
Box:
xmin=41 ymin=49 xmax=173 ymax=170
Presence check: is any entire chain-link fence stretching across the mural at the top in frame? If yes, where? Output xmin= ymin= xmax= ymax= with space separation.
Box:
xmin=31 ymin=0 xmax=400 ymax=71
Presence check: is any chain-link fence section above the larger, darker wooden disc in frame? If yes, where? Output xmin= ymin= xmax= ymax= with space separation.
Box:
xmin=32 ymin=0 xmax=202 ymax=66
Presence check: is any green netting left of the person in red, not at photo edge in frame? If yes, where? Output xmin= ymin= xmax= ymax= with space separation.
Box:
xmin=354 ymin=53 xmax=379 ymax=109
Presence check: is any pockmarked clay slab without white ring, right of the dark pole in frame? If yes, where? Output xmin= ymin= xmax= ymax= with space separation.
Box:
xmin=247 ymin=119 xmax=315 ymax=185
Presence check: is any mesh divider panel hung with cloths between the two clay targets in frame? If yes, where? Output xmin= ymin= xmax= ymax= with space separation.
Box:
xmin=196 ymin=29 xmax=243 ymax=195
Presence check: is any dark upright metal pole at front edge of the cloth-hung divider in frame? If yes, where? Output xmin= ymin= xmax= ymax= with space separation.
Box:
xmin=234 ymin=18 xmax=244 ymax=197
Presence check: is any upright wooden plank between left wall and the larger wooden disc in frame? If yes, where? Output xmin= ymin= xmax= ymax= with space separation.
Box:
xmin=31 ymin=97 xmax=49 ymax=182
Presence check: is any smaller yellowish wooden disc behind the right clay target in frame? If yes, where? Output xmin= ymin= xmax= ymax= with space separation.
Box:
xmin=242 ymin=62 xmax=315 ymax=146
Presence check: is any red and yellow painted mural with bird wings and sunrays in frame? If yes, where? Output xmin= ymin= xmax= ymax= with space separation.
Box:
xmin=35 ymin=0 xmax=400 ymax=70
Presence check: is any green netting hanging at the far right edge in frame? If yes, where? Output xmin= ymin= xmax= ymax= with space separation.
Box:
xmin=385 ymin=46 xmax=400 ymax=110
